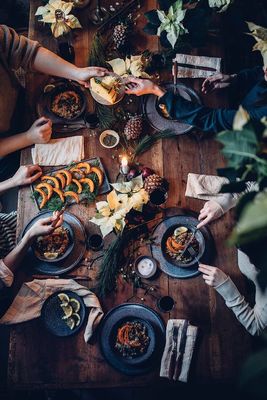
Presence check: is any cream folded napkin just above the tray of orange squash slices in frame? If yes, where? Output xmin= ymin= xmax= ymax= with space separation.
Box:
xmin=32 ymin=136 xmax=84 ymax=166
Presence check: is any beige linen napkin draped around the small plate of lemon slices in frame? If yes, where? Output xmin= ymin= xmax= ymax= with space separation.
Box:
xmin=0 ymin=279 xmax=104 ymax=342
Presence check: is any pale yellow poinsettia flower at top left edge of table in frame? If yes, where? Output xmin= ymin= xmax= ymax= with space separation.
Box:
xmin=35 ymin=0 xmax=82 ymax=38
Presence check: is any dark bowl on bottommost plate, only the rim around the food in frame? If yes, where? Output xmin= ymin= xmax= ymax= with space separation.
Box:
xmin=109 ymin=317 xmax=156 ymax=365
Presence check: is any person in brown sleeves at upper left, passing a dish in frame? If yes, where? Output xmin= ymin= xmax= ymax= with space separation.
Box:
xmin=0 ymin=25 xmax=107 ymax=180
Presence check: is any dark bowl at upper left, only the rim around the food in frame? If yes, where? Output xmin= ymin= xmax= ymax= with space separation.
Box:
xmin=46 ymin=82 xmax=86 ymax=122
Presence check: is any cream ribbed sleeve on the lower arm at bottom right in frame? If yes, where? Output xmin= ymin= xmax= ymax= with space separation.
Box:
xmin=215 ymin=276 xmax=267 ymax=335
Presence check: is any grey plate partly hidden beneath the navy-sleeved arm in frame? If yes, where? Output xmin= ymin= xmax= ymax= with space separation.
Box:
xmin=142 ymin=83 xmax=201 ymax=135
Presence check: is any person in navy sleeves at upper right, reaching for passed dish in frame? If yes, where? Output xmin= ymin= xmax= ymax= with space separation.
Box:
xmin=126 ymin=66 xmax=267 ymax=133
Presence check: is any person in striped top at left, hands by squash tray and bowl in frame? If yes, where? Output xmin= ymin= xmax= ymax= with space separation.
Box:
xmin=0 ymin=165 xmax=62 ymax=289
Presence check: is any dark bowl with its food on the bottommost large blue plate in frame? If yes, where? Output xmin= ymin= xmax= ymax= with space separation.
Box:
xmin=110 ymin=317 xmax=156 ymax=365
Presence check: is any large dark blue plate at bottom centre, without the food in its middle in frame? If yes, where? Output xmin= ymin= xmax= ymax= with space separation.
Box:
xmin=99 ymin=303 xmax=165 ymax=375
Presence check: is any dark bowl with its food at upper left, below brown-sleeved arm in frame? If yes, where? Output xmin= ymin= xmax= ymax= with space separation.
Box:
xmin=46 ymin=82 xmax=86 ymax=122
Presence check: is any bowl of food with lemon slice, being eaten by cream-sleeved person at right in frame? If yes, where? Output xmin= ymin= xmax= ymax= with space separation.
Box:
xmin=161 ymin=225 xmax=205 ymax=268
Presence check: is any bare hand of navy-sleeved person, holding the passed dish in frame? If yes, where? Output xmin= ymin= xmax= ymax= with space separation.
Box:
xmin=125 ymin=77 xmax=165 ymax=97
